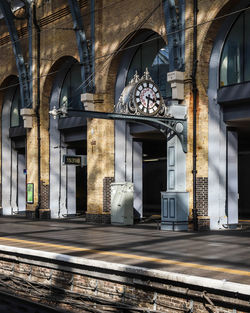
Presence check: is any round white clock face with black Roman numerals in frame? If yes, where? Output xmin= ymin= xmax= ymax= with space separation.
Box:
xmin=134 ymin=80 xmax=161 ymax=115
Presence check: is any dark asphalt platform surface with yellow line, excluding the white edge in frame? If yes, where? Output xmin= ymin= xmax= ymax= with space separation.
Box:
xmin=0 ymin=217 xmax=250 ymax=285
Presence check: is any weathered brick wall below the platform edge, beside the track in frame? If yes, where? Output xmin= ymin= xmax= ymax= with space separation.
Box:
xmin=0 ymin=252 xmax=247 ymax=313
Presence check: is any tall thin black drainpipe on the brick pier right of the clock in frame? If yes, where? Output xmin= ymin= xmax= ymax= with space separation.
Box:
xmin=192 ymin=0 xmax=198 ymax=231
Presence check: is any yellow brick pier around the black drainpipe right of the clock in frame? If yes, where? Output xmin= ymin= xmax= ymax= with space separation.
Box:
xmin=185 ymin=0 xmax=233 ymax=213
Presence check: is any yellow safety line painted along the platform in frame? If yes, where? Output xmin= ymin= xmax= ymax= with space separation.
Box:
xmin=0 ymin=237 xmax=250 ymax=276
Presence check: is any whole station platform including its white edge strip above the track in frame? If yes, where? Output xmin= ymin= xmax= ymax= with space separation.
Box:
xmin=0 ymin=217 xmax=250 ymax=312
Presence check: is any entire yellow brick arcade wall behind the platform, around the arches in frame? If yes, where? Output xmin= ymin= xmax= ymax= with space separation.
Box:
xmin=0 ymin=0 xmax=240 ymax=218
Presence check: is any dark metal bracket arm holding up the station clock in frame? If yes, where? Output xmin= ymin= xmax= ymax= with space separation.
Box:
xmin=66 ymin=109 xmax=187 ymax=153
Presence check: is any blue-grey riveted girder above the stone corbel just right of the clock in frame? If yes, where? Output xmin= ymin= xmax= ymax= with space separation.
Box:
xmin=163 ymin=0 xmax=185 ymax=72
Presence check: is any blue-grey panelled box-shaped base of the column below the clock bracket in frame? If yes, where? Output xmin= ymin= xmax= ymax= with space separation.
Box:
xmin=161 ymin=191 xmax=189 ymax=231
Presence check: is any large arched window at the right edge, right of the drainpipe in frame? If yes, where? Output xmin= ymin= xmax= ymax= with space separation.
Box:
xmin=220 ymin=10 xmax=250 ymax=87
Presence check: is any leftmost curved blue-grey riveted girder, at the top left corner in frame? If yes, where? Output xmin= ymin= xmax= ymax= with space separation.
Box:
xmin=0 ymin=0 xmax=31 ymax=108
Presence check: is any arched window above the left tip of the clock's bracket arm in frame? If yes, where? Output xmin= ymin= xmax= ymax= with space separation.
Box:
xmin=60 ymin=64 xmax=82 ymax=109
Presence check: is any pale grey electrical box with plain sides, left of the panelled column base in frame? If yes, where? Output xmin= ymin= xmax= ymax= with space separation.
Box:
xmin=111 ymin=182 xmax=134 ymax=225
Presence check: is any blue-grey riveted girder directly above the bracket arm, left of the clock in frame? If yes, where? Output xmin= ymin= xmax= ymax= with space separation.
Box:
xmin=68 ymin=0 xmax=94 ymax=93
